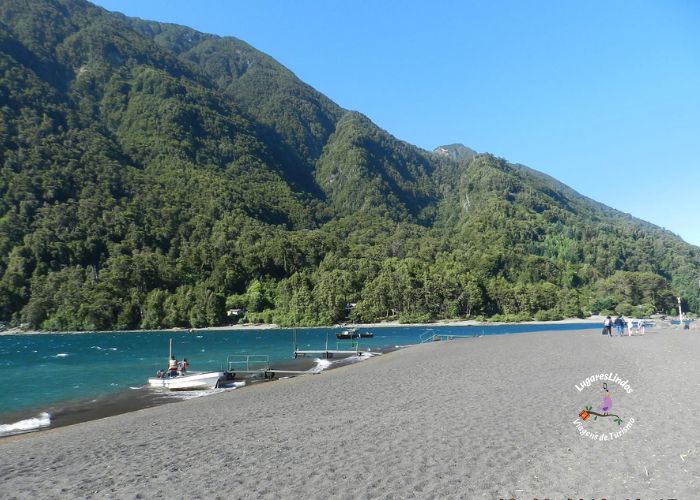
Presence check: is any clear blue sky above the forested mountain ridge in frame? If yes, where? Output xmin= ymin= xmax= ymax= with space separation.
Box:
xmin=96 ymin=0 xmax=700 ymax=245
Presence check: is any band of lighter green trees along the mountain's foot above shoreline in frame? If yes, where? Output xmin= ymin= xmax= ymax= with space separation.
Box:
xmin=2 ymin=213 xmax=688 ymax=330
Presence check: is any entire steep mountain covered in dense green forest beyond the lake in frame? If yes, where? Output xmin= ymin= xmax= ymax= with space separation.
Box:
xmin=0 ymin=0 xmax=700 ymax=330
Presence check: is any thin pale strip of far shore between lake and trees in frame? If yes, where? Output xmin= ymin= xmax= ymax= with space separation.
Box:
xmin=0 ymin=316 xmax=604 ymax=335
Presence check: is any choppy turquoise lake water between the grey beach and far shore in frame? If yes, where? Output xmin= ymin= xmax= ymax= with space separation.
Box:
xmin=0 ymin=323 xmax=595 ymax=432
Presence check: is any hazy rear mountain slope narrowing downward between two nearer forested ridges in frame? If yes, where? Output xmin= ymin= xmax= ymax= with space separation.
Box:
xmin=131 ymin=20 xmax=344 ymax=197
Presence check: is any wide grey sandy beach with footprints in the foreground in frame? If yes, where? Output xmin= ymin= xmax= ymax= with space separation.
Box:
xmin=0 ymin=327 xmax=700 ymax=499
